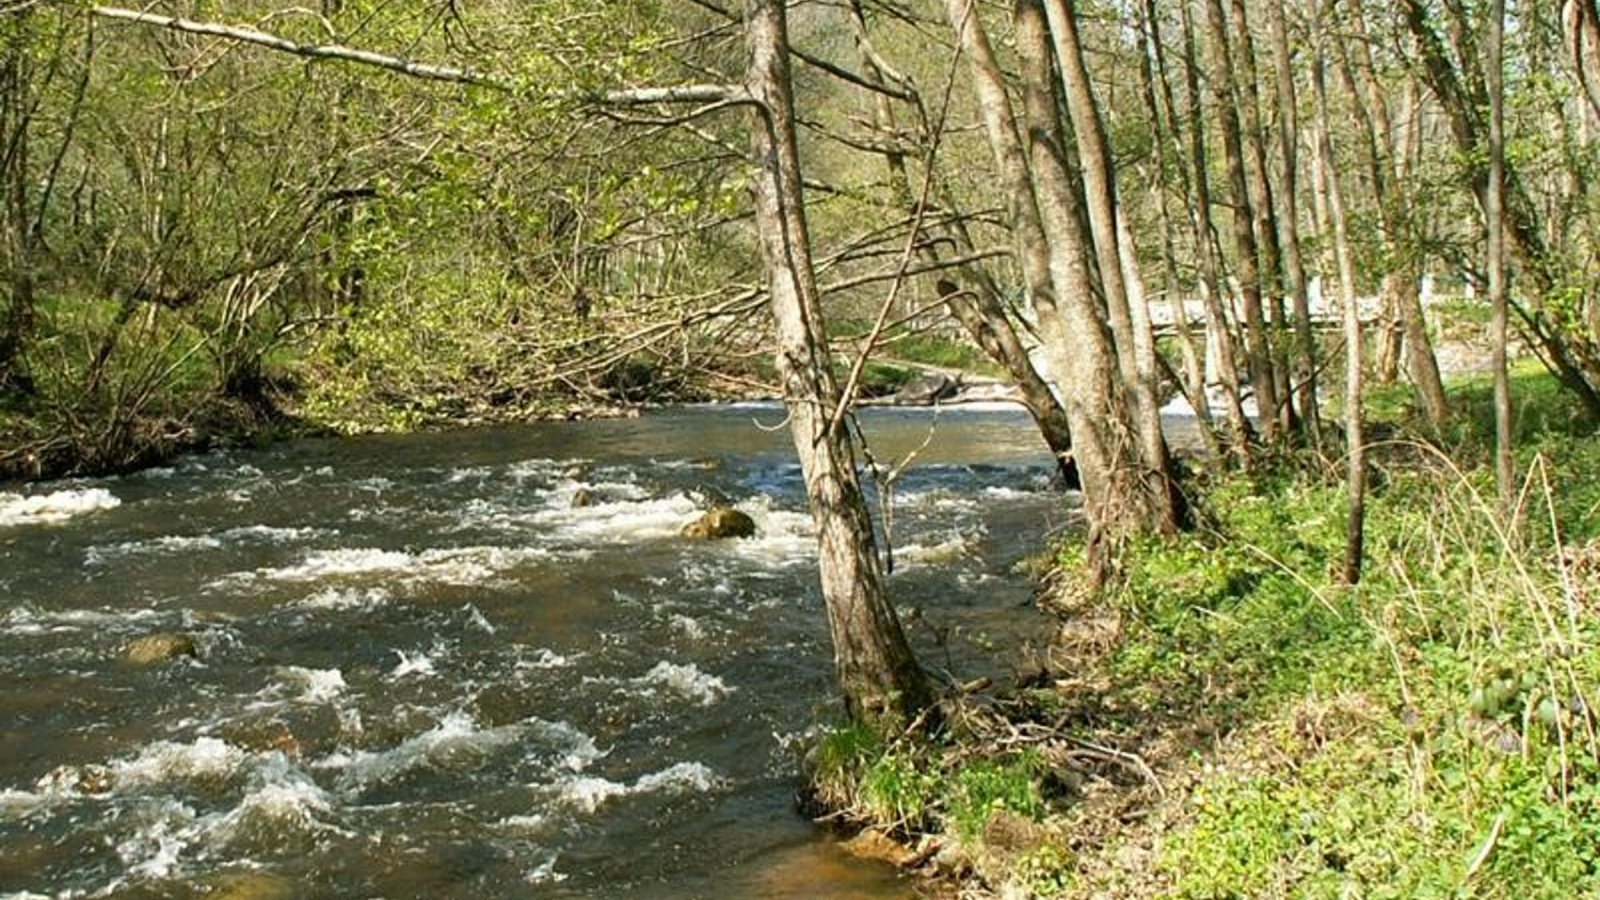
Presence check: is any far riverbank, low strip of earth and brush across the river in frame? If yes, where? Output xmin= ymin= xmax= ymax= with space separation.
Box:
xmin=0 ymin=343 xmax=1014 ymax=484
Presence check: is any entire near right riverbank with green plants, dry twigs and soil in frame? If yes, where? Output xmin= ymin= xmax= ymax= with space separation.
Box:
xmin=811 ymin=366 xmax=1600 ymax=900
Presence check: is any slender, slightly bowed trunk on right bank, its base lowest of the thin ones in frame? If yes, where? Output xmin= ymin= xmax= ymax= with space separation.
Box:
xmin=1312 ymin=0 xmax=1366 ymax=585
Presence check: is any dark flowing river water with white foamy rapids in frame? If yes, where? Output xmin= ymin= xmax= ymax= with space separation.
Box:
xmin=0 ymin=405 xmax=1069 ymax=900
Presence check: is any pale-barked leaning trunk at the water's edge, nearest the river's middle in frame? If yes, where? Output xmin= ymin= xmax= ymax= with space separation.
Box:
xmin=746 ymin=0 xmax=933 ymax=733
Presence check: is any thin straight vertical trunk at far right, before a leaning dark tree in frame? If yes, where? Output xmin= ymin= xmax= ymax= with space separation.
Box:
xmin=1483 ymin=0 xmax=1517 ymax=509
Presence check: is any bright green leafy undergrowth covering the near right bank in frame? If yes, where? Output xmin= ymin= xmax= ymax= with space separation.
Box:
xmin=1118 ymin=439 xmax=1600 ymax=900
